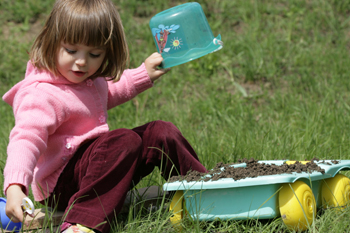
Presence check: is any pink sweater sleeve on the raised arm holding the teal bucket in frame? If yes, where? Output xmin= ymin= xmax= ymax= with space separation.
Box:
xmin=108 ymin=63 xmax=153 ymax=109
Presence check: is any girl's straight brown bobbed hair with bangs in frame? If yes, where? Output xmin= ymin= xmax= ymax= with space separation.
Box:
xmin=29 ymin=0 xmax=129 ymax=80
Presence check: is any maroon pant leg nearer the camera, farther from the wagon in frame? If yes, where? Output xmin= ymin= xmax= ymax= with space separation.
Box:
xmin=49 ymin=129 xmax=142 ymax=232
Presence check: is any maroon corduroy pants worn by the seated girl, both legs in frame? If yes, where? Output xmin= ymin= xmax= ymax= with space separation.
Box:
xmin=42 ymin=121 xmax=207 ymax=232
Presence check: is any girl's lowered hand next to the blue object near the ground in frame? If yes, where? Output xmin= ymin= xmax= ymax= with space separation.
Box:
xmin=5 ymin=184 xmax=26 ymax=223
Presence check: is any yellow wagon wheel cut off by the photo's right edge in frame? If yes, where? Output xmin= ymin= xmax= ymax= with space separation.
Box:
xmin=322 ymin=174 xmax=350 ymax=207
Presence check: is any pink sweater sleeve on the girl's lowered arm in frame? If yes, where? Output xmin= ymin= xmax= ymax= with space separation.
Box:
xmin=4 ymin=87 xmax=65 ymax=194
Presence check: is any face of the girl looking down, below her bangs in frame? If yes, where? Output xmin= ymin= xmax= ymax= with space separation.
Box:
xmin=57 ymin=41 xmax=106 ymax=83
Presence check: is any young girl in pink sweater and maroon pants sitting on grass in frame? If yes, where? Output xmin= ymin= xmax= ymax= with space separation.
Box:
xmin=3 ymin=0 xmax=206 ymax=232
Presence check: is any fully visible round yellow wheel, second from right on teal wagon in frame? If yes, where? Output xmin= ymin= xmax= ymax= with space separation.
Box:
xmin=278 ymin=180 xmax=316 ymax=231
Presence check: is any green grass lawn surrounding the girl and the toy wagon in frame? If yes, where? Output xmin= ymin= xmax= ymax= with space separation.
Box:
xmin=0 ymin=0 xmax=350 ymax=232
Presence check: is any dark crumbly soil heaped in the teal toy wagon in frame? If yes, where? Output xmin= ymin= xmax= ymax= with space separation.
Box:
xmin=168 ymin=158 xmax=339 ymax=183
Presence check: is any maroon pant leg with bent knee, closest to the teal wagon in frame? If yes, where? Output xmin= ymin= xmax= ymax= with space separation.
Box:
xmin=133 ymin=121 xmax=207 ymax=184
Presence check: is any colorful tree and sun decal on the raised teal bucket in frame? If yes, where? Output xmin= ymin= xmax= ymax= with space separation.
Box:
xmin=152 ymin=24 xmax=182 ymax=53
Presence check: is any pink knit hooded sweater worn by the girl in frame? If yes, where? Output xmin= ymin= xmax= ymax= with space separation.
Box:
xmin=3 ymin=62 xmax=153 ymax=201
